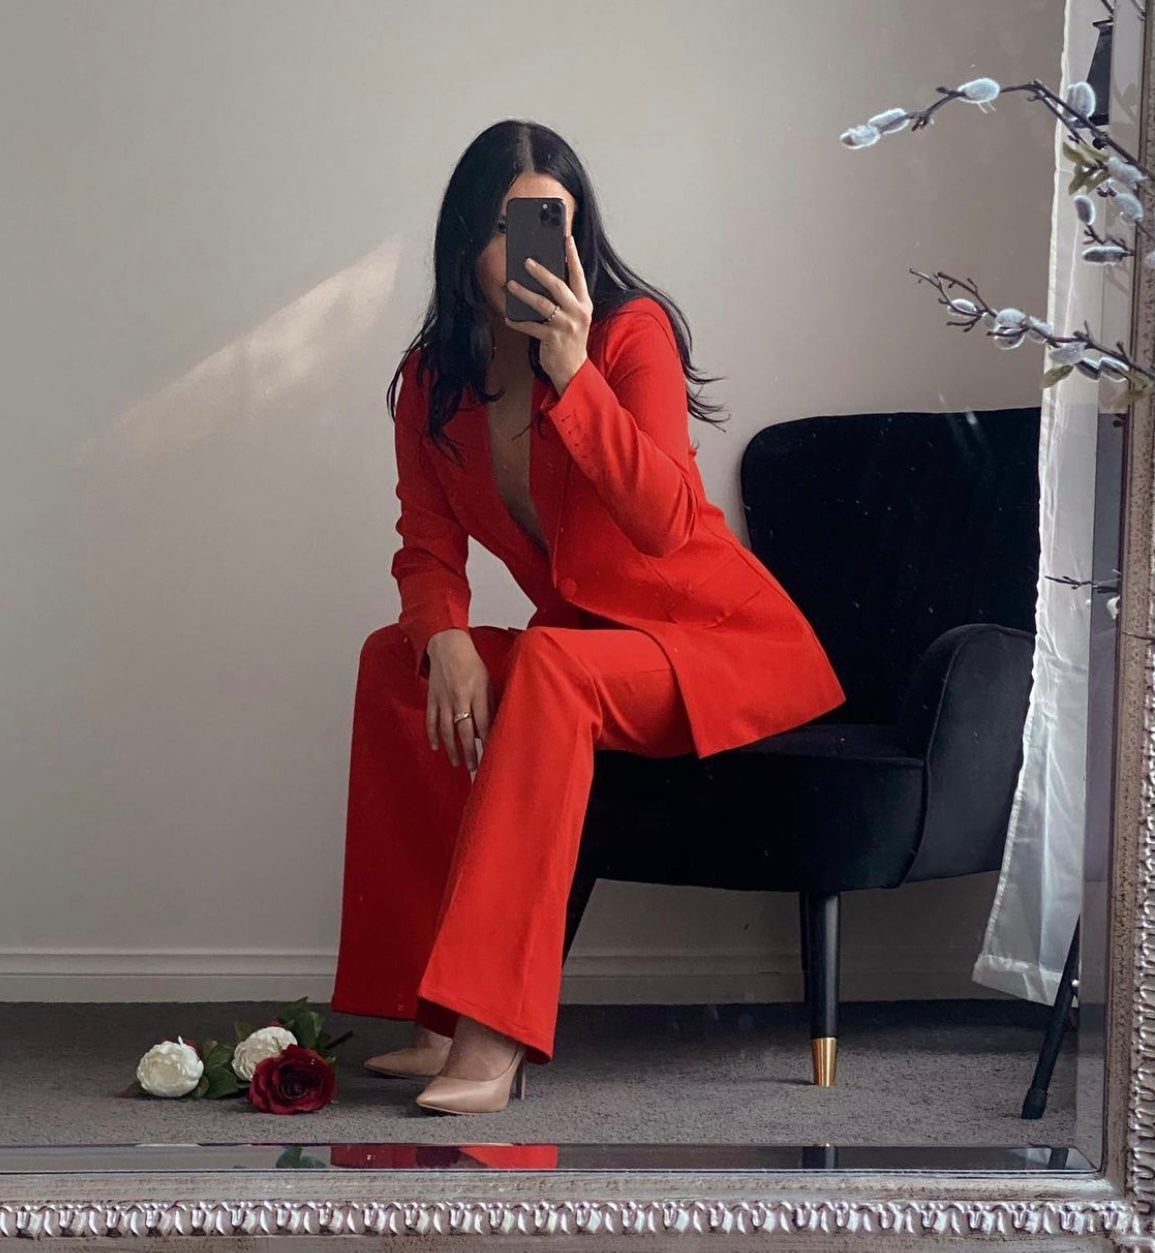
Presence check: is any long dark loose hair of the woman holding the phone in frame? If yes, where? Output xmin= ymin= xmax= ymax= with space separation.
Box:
xmin=386 ymin=118 xmax=725 ymax=462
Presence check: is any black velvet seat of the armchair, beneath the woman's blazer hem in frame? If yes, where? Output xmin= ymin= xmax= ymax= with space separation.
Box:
xmin=581 ymin=723 xmax=923 ymax=892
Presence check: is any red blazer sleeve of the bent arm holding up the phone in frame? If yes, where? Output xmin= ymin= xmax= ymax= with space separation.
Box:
xmin=542 ymin=302 xmax=698 ymax=556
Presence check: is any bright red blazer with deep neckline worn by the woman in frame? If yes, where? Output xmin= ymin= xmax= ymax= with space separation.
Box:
xmin=392 ymin=297 xmax=846 ymax=757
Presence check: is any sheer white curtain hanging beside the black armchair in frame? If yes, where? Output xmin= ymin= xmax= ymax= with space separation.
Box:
xmin=972 ymin=0 xmax=1105 ymax=1002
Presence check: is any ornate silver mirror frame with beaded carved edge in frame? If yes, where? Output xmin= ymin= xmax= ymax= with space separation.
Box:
xmin=0 ymin=4 xmax=1155 ymax=1253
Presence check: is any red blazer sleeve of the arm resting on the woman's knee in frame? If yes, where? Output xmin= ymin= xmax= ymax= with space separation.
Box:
xmin=391 ymin=351 xmax=470 ymax=675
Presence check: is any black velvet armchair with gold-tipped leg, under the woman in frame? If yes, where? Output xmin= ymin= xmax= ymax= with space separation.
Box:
xmin=565 ymin=407 xmax=1040 ymax=1085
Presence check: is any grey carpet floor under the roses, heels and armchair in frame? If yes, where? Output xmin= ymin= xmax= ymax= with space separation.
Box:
xmin=0 ymin=1000 xmax=1076 ymax=1145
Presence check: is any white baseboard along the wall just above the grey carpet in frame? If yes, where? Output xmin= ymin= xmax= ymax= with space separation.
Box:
xmin=0 ymin=945 xmax=1010 ymax=1005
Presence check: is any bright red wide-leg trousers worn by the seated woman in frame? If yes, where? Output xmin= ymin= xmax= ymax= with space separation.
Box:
xmin=331 ymin=611 xmax=693 ymax=1063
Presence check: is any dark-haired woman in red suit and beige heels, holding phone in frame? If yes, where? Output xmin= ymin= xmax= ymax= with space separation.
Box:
xmin=332 ymin=120 xmax=844 ymax=1114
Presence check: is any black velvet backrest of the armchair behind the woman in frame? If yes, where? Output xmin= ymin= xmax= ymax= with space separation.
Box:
xmin=742 ymin=406 xmax=1042 ymax=723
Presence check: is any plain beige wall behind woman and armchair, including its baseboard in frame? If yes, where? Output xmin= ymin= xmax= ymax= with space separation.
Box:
xmin=0 ymin=0 xmax=1062 ymax=1000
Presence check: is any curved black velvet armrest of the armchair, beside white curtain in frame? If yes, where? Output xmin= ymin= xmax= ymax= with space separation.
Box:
xmin=896 ymin=623 xmax=1035 ymax=882
